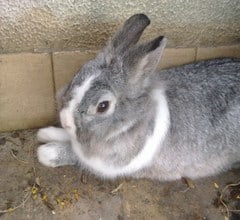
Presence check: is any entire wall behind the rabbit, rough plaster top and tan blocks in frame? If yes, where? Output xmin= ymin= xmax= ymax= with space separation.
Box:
xmin=0 ymin=0 xmax=240 ymax=131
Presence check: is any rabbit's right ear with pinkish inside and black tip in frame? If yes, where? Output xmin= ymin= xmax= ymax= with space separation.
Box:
xmin=124 ymin=36 xmax=167 ymax=82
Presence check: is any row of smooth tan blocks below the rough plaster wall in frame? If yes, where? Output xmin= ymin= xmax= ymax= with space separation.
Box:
xmin=0 ymin=45 xmax=240 ymax=131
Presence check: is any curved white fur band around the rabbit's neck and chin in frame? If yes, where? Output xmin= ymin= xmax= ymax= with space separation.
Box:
xmin=72 ymin=90 xmax=170 ymax=178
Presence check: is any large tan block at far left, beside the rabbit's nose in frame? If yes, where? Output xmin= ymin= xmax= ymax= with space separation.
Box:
xmin=0 ymin=53 xmax=55 ymax=131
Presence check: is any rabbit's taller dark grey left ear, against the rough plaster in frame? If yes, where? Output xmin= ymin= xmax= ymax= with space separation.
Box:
xmin=110 ymin=14 xmax=150 ymax=54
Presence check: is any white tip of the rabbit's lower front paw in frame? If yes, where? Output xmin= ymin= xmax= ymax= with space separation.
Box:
xmin=37 ymin=144 xmax=59 ymax=167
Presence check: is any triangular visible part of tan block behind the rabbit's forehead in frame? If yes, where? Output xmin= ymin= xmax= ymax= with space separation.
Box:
xmin=53 ymin=51 xmax=96 ymax=90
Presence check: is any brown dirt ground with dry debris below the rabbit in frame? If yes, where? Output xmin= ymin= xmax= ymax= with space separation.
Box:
xmin=0 ymin=130 xmax=240 ymax=220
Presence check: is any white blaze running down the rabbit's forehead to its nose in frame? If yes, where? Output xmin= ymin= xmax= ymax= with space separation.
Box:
xmin=60 ymin=75 xmax=98 ymax=137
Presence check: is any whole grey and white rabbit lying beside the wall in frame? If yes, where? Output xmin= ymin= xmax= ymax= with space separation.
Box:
xmin=37 ymin=14 xmax=240 ymax=181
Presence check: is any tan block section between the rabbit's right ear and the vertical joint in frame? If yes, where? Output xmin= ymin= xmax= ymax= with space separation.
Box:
xmin=159 ymin=48 xmax=196 ymax=69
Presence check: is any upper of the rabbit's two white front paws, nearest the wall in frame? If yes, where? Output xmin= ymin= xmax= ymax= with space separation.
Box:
xmin=37 ymin=127 xmax=70 ymax=143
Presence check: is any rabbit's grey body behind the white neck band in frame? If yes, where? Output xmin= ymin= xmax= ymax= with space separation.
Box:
xmin=145 ymin=59 xmax=240 ymax=179
